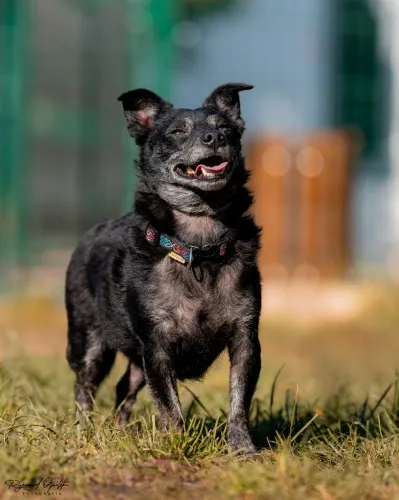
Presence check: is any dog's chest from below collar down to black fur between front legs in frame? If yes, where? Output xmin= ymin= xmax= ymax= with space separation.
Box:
xmin=146 ymin=257 xmax=252 ymax=380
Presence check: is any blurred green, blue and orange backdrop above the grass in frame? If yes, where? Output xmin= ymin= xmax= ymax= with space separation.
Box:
xmin=0 ymin=0 xmax=399 ymax=308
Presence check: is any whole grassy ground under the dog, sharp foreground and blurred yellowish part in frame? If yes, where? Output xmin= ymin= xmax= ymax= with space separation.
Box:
xmin=0 ymin=289 xmax=399 ymax=500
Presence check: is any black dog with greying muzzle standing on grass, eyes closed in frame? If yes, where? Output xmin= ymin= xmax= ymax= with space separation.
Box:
xmin=66 ymin=84 xmax=261 ymax=452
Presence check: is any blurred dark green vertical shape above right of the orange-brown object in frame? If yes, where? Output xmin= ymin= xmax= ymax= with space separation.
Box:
xmin=332 ymin=0 xmax=389 ymax=166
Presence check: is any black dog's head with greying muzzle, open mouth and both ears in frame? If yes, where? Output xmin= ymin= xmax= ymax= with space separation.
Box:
xmin=119 ymin=83 xmax=253 ymax=194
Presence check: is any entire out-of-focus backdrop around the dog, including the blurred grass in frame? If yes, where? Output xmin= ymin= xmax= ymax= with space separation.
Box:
xmin=0 ymin=0 xmax=399 ymax=456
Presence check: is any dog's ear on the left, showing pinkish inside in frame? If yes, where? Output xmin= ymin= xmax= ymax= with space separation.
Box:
xmin=118 ymin=89 xmax=173 ymax=144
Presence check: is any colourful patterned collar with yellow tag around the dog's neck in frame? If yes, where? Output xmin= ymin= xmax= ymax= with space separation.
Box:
xmin=145 ymin=224 xmax=235 ymax=268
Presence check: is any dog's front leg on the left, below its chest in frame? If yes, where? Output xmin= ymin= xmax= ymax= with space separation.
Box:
xmin=143 ymin=345 xmax=184 ymax=429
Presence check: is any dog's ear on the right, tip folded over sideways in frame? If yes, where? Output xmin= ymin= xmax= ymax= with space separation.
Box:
xmin=204 ymin=83 xmax=253 ymax=130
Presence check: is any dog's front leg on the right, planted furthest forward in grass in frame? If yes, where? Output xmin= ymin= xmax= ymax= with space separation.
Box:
xmin=228 ymin=320 xmax=261 ymax=453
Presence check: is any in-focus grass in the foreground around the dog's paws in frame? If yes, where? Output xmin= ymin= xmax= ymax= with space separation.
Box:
xmin=0 ymin=358 xmax=399 ymax=499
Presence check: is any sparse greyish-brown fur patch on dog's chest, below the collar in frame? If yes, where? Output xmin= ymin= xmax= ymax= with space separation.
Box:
xmin=146 ymin=256 xmax=248 ymax=338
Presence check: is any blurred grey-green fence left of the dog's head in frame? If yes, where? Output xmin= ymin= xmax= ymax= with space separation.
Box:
xmin=0 ymin=0 xmax=178 ymax=285
